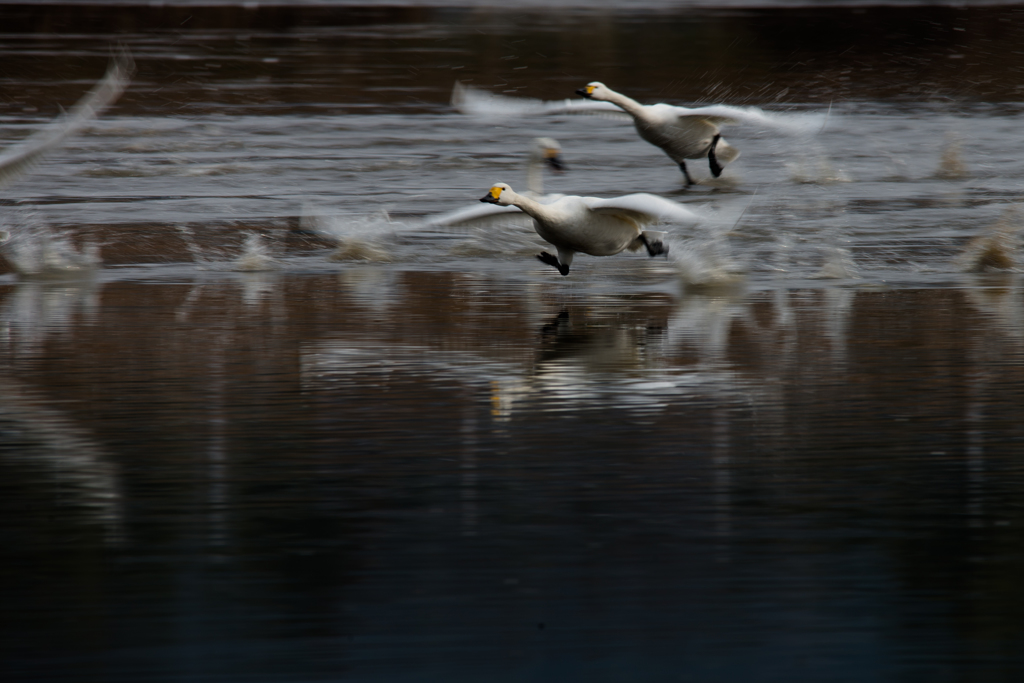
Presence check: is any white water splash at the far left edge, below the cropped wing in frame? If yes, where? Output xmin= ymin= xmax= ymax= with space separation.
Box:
xmin=0 ymin=215 xmax=102 ymax=279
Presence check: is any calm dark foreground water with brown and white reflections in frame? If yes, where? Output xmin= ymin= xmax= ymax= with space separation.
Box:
xmin=0 ymin=266 xmax=1024 ymax=680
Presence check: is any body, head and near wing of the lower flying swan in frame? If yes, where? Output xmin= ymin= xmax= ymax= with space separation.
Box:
xmin=480 ymin=182 xmax=697 ymax=275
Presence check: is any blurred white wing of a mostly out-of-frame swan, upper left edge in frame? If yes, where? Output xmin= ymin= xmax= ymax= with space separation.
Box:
xmin=0 ymin=50 xmax=135 ymax=187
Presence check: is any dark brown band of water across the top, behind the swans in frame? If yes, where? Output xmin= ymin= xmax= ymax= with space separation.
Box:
xmin=6 ymin=3 xmax=1024 ymax=116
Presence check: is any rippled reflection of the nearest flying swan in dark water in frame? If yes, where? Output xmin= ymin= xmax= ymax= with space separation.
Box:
xmin=302 ymin=288 xmax=778 ymax=421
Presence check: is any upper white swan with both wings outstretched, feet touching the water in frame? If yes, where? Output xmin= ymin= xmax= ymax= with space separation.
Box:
xmin=452 ymin=81 xmax=826 ymax=185
